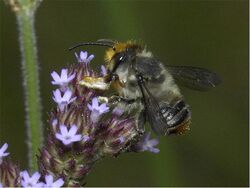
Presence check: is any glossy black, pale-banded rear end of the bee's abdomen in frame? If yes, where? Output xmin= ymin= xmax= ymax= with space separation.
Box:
xmin=160 ymin=100 xmax=191 ymax=134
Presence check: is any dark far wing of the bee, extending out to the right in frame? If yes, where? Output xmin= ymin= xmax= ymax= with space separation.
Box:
xmin=167 ymin=66 xmax=222 ymax=90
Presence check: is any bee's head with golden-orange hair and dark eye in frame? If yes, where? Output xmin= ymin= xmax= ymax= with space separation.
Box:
xmin=105 ymin=41 xmax=143 ymax=73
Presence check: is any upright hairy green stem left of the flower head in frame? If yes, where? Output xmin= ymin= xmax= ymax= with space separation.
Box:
xmin=10 ymin=0 xmax=43 ymax=170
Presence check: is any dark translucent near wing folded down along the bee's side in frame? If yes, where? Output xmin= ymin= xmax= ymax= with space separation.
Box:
xmin=139 ymin=79 xmax=167 ymax=135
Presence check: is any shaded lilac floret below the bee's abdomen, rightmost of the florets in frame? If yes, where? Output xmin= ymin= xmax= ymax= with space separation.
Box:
xmin=135 ymin=132 xmax=160 ymax=153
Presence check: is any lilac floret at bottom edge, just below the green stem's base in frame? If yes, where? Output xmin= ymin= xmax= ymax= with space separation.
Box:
xmin=20 ymin=170 xmax=44 ymax=187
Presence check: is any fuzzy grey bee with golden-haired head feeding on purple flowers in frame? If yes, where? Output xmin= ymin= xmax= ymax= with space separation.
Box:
xmin=70 ymin=39 xmax=221 ymax=135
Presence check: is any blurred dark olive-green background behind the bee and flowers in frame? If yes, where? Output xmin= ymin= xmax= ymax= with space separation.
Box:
xmin=0 ymin=0 xmax=249 ymax=186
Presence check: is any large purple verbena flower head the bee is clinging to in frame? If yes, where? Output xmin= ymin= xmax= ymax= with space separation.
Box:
xmin=38 ymin=49 xmax=149 ymax=187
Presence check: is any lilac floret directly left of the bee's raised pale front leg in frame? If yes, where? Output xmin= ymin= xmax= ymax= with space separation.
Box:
xmin=51 ymin=69 xmax=75 ymax=86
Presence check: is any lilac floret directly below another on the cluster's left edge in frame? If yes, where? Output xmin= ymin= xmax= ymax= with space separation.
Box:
xmin=53 ymin=89 xmax=76 ymax=111
